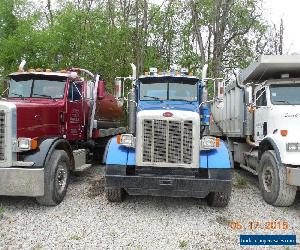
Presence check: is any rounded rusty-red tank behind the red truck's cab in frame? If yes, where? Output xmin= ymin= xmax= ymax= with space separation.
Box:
xmin=95 ymin=93 xmax=123 ymax=129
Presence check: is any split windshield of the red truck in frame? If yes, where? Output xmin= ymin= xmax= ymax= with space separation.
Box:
xmin=8 ymin=75 xmax=66 ymax=99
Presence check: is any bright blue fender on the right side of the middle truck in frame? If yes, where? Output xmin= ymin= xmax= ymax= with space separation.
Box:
xmin=207 ymin=140 xmax=233 ymax=169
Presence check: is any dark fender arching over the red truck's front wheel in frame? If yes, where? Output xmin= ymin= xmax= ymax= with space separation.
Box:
xmin=23 ymin=137 xmax=74 ymax=170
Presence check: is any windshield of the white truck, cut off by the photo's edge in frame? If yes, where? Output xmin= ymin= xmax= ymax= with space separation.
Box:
xmin=270 ymin=83 xmax=300 ymax=105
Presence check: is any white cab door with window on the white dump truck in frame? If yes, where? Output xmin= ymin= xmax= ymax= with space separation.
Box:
xmin=254 ymin=88 xmax=269 ymax=143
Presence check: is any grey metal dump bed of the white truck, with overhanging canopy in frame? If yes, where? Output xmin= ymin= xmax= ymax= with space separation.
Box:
xmin=210 ymin=55 xmax=300 ymax=138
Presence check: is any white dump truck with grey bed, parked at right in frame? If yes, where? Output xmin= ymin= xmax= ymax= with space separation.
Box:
xmin=210 ymin=55 xmax=300 ymax=206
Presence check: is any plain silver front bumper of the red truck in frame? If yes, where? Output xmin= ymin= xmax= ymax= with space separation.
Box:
xmin=0 ymin=168 xmax=44 ymax=197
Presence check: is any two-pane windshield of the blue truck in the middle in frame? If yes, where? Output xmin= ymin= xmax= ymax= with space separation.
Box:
xmin=140 ymin=77 xmax=198 ymax=101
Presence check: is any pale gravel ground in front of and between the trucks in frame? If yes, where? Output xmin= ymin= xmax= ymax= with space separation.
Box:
xmin=0 ymin=167 xmax=300 ymax=249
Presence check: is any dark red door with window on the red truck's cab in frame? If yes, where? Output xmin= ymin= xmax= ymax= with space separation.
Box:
xmin=66 ymin=81 xmax=84 ymax=141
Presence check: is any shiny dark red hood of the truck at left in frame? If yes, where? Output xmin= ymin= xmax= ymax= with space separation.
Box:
xmin=8 ymin=99 xmax=65 ymax=138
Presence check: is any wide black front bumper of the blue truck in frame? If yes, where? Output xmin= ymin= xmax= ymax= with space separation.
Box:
xmin=105 ymin=166 xmax=232 ymax=198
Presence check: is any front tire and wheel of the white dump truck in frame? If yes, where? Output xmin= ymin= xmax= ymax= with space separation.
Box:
xmin=258 ymin=150 xmax=297 ymax=207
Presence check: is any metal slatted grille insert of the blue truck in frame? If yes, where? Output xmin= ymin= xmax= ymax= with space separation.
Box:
xmin=142 ymin=119 xmax=193 ymax=164
